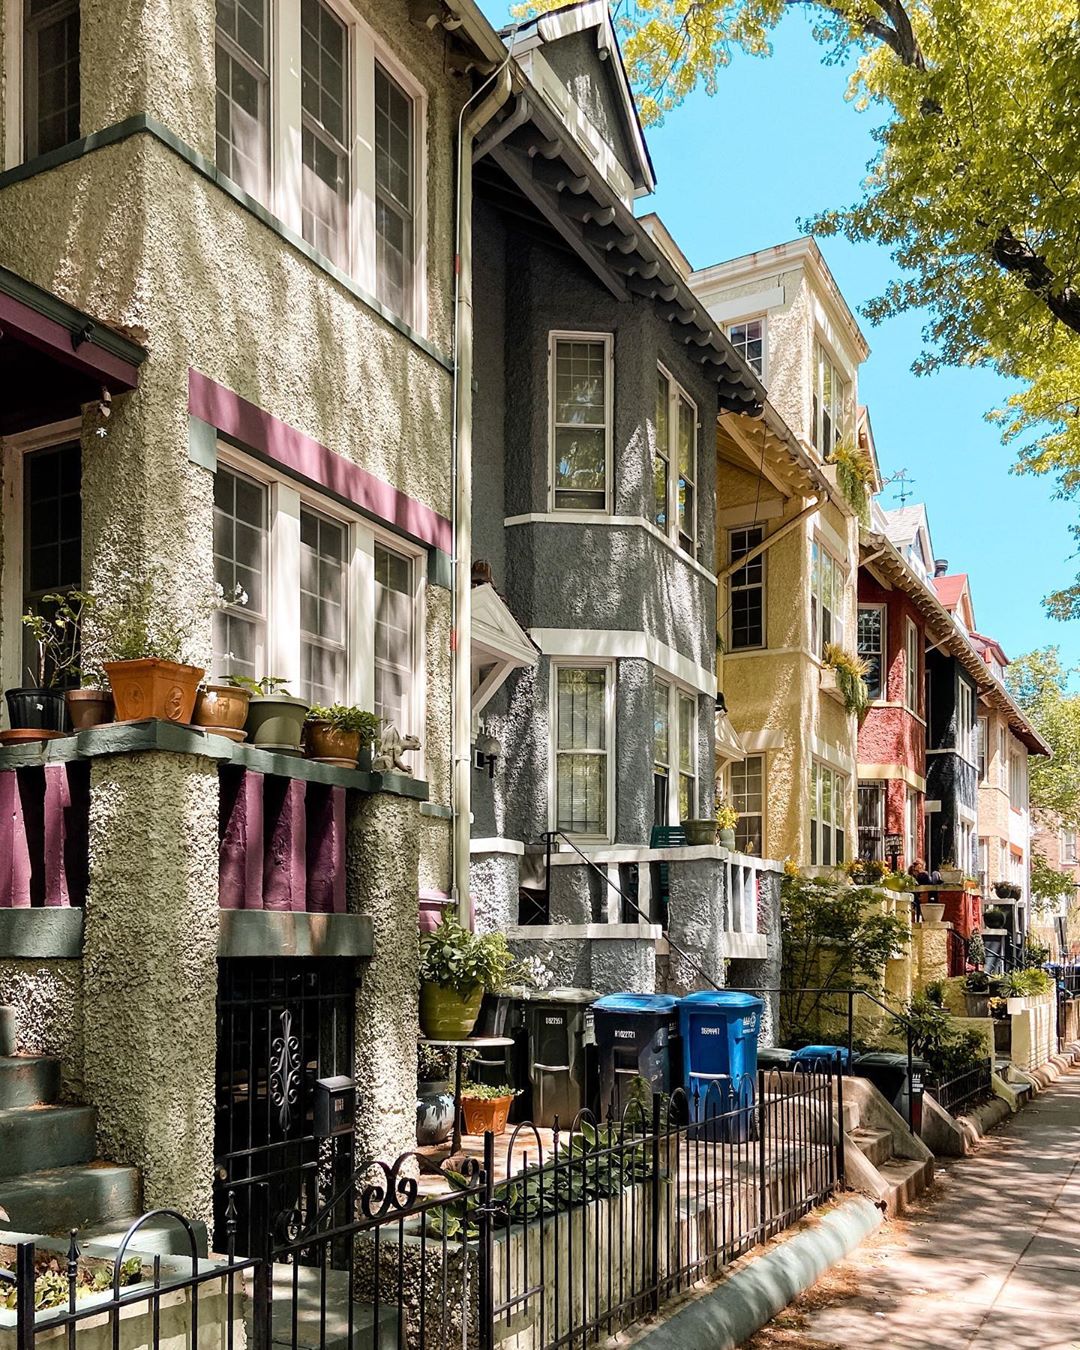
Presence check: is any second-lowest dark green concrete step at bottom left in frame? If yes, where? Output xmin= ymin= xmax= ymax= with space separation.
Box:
xmin=0 ymin=1162 xmax=142 ymax=1238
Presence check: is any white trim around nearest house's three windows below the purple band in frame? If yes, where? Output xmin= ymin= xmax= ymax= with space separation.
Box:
xmin=217 ymin=441 xmax=427 ymax=761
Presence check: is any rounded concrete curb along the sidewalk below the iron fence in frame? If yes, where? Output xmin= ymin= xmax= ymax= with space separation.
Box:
xmin=630 ymin=1195 xmax=884 ymax=1350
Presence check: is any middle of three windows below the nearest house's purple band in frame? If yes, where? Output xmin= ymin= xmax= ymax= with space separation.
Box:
xmin=300 ymin=508 xmax=345 ymax=707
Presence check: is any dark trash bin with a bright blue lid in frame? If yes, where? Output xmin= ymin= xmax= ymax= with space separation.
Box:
xmin=593 ymin=994 xmax=682 ymax=1116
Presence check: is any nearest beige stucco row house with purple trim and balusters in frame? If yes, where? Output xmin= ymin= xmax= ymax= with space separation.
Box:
xmin=0 ymin=0 xmax=510 ymax=1250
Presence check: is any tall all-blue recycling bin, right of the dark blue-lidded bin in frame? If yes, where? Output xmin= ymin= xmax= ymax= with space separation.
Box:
xmin=679 ymin=990 xmax=764 ymax=1141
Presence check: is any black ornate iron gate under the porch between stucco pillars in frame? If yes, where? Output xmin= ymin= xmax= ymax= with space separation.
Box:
xmin=213 ymin=959 xmax=356 ymax=1254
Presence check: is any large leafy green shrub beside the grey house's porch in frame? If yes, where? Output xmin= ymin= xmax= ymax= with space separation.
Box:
xmin=780 ymin=873 xmax=911 ymax=1041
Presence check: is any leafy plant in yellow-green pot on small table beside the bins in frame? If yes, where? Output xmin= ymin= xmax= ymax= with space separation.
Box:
xmin=420 ymin=914 xmax=516 ymax=1041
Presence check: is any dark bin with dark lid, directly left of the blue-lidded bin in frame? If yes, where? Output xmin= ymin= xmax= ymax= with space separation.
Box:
xmin=525 ymin=990 xmax=599 ymax=1130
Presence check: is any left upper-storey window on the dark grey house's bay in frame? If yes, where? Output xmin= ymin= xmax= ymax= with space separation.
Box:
xmin=549 ymin=333 xmax=612 ymax=512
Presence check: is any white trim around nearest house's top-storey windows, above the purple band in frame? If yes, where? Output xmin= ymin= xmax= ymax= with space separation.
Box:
xmin=263 ymin=0 xmax=428 ymax=336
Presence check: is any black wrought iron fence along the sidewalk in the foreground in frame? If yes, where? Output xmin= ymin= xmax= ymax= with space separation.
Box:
xmin=8 ymin=1062 xmax=844 ymax=1350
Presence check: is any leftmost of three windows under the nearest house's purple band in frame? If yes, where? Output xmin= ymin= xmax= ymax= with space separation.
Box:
xmin=213 ymin=466 xmax=267 ymax=680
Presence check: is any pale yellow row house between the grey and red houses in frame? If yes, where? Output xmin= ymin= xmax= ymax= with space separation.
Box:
xmin=690 ymin=239 xmax=876 ymax=868
